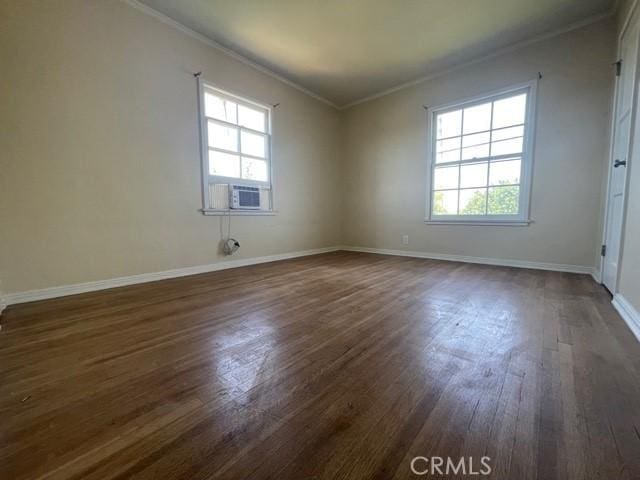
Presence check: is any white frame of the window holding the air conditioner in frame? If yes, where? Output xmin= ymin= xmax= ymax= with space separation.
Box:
xmin=198 ymin=78 xmax=274 ymax=215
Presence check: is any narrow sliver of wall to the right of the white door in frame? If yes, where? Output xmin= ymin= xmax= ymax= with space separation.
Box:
xmin=618 ymin=1 xmax=640 ymax=312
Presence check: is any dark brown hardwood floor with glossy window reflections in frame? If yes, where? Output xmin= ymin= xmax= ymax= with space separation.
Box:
xmin=0 ymin=252 xmax=640 ymax=480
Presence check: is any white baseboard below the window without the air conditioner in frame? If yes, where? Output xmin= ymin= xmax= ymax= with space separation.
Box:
xmin=340 ymin=246 xmax=594 ymax=276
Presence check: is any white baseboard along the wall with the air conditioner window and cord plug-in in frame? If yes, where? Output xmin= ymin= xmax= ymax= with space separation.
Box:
xmin=0 ymin=247 xmax=340 ymax=306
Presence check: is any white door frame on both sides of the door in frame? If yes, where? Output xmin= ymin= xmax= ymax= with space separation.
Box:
xmin=598 ymin=0 xmax=640 ymax=295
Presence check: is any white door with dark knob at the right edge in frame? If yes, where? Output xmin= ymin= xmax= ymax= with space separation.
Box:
xmin=602 ymin=16 xmax=639 ymax=293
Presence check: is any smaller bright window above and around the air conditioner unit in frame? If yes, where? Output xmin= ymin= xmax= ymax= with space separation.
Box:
xmin=199 ymin=81 xmax=271 ymax=213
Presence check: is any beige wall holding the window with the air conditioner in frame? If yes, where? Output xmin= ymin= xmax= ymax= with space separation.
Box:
xmin=0 ymin=0 xmax=340 ymax=293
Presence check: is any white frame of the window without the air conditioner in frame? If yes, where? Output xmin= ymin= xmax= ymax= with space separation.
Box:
xmin=425 ymin=80 xmax=538 ymax=226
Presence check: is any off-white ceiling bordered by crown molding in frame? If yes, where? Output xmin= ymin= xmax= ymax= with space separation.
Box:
xmin=140 ymin=0 xmax=615 ymax=106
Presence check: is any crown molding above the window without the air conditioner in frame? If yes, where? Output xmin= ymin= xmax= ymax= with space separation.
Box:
xmin=339 ymin=8 xmax=616 ymax=110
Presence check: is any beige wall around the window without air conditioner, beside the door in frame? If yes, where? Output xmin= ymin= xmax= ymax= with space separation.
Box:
xmin=343 ymin=20 xmax=615 ymax=267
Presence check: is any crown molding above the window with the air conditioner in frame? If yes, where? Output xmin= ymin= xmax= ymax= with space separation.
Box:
xmin=121 ymin=0 xmax=340 ymax=109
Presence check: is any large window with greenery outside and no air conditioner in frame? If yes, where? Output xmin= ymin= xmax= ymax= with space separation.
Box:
xmin=427 ymin=83 xmax=535 ymax=223
